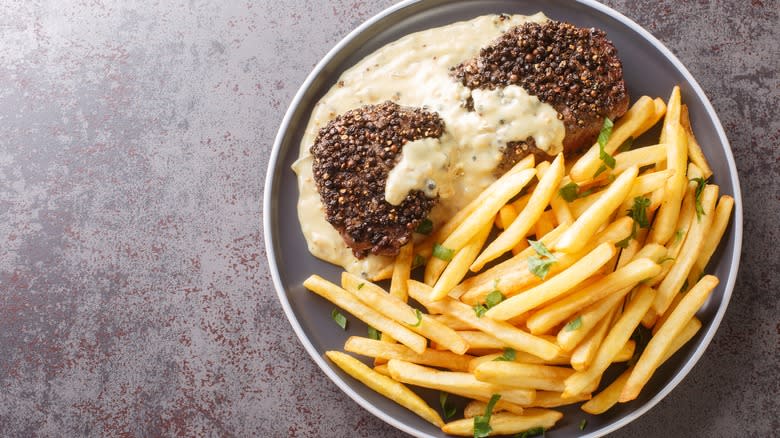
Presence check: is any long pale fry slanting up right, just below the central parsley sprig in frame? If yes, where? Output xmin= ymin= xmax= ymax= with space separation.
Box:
xmin=486 ymin=243 xmax=616 ymax=320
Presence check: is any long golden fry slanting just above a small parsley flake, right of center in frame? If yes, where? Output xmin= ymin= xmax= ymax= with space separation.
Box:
xmin=528 ymin=258 xmax=661 ymax=334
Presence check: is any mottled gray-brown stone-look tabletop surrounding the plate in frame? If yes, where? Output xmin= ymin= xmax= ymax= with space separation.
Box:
xmin=0 ymin=0 xmax=780 ymax=437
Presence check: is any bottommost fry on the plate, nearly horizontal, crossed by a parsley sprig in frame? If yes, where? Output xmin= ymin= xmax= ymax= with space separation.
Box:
xmin=441 ymin=408 xmax=563 ymax=436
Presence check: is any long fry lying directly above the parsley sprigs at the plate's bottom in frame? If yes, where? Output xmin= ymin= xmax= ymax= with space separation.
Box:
xmin=387 ymin=359 xmax=536 ymax=405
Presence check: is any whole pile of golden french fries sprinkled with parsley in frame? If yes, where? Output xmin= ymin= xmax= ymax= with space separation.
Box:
xmin=304 ymin=87 xmax=734 ymax=436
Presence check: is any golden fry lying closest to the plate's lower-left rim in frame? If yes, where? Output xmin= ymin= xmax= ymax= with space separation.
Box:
xmin=325 ymin=351 xmax=444 ymax=427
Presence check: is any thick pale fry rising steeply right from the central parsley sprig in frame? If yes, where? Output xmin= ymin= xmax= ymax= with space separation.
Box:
xmin=555 ymin=167 xmax=638 ymax=253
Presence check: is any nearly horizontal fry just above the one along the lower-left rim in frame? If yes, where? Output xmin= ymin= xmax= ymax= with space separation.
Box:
xmin=344 ymin=336 xmax=474 ymax=372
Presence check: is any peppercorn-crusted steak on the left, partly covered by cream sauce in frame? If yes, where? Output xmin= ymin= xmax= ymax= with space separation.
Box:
xmin=311 ymin=101 xmax=444 ymax=258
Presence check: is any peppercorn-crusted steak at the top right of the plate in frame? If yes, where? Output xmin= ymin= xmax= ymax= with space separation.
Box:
xmin=453 ymin=20 xmax=628 ymax=173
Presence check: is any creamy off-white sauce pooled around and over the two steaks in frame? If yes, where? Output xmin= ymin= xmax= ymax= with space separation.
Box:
xmin=292 ymin=13 xmax=565 ymax=277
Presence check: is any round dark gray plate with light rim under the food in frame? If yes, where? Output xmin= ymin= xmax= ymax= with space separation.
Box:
xmin=263 ymin=0 xmax=742 ymax=438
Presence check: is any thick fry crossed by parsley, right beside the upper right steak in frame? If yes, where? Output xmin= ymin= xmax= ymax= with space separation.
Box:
xmin=570 ymin=96 xmax=655 ymax=183
